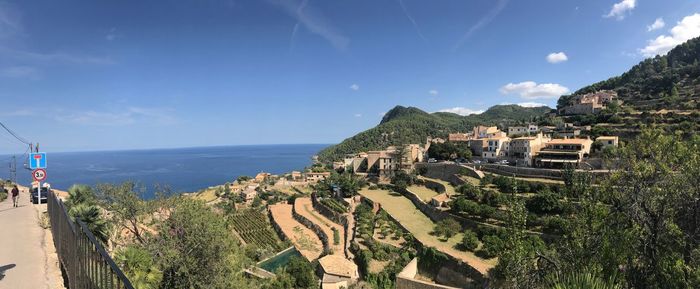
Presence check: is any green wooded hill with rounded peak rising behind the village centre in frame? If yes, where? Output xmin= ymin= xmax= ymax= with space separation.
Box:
xmin=318 ymin=105 xmax=551 ymax=162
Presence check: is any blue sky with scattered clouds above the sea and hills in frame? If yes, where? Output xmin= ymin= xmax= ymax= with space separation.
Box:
xmin=0 ymin=0 xmax=700 ymax=153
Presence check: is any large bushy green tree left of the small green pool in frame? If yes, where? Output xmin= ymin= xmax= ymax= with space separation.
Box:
xmin=154 ymin=197 xmax=249 ymax=289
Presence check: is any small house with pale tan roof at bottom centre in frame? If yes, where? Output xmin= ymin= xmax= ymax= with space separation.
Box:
xmin=318 ymin=254 xmax=360 ymax=289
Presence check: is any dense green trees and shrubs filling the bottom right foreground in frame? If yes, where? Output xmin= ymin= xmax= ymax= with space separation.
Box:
xmin=484 ymin=130 xmax=700 ymax=288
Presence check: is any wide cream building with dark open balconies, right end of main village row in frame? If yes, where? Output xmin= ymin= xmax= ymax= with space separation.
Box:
xmin=535 ymin=138 xmax=593 ymax=168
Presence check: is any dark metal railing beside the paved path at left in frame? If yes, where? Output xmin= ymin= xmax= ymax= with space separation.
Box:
xmin=47 ymin=192 xmax=134 ymax=289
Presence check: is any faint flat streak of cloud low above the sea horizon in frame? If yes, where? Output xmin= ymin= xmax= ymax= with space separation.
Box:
xmin=55 ymin=107 xmax=177 ymax=126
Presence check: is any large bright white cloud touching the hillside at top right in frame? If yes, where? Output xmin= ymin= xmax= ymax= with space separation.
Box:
xmin=639 ymin=13 xmax=700 ymax=57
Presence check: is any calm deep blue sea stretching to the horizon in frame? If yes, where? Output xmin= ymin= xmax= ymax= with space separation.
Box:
xmin=0 ymin=144 xmax=328 ymax=197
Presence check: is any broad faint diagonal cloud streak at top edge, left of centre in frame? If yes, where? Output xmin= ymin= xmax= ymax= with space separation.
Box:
xmin=268 ymin=0 xmax=350 ymax=50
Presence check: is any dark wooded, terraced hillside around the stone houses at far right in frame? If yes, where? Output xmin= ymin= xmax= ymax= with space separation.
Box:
xmin=557 ymin=38 xmax=700 ymax=139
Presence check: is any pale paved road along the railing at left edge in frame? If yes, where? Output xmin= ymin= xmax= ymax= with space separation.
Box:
xmin=0 ymin=191 xmax=49 ymax=289
